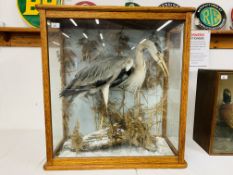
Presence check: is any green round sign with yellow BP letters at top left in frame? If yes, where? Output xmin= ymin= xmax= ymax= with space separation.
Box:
xmin=17 ymin=0 xmax=62 ymax=27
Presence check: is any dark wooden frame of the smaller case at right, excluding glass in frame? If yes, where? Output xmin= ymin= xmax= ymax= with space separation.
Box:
xmin=193 ymin=69 xmax=233 ymax=156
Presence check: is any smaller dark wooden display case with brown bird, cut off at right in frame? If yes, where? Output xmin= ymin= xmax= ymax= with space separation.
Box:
xmin=194 ymin=70 xmax=233 ymax=155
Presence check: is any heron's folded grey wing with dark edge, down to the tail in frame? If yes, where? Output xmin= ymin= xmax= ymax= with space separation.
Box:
xmin=60 ymin=57 xmax=129 ymax=96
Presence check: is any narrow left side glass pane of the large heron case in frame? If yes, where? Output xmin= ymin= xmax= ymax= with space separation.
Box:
xmin=48 ymin=30 xmax=64 ymax=151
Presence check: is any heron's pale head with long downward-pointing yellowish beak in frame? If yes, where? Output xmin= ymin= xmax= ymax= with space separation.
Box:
xmin=137 ymin=39 xmax=168 ymax=77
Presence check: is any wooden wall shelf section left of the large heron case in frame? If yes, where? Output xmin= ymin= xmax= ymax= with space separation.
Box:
xmin=0 ymin=27 xmax=40 ymax=47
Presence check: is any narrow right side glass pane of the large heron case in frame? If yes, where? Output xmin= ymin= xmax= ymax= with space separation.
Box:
xmin=166 ymin=24 xmax=184 ymax=150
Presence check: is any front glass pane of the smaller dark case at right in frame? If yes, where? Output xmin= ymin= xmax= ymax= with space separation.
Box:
xmin=213 ymin=73 xmax=233 ymax=153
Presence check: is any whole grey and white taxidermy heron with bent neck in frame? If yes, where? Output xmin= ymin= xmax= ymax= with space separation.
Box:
xmin=60 ymin=39 xmax=168 ymax=107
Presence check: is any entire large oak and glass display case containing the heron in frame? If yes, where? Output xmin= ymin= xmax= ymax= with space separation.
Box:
xmin=38 ymin=6 xmax=194 ymax=169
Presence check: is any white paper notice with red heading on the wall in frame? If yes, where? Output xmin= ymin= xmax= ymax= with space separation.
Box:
xmin=190 ymin=30 xmax=210 ymax=71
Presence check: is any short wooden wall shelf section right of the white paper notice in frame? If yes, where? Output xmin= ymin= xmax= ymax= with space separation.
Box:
xmin=210 ymin=30 xmax=233 ymax=49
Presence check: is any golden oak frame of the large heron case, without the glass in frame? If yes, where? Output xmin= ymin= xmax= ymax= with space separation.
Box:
xmin=37 ymin=5 xmax=195 ymax=170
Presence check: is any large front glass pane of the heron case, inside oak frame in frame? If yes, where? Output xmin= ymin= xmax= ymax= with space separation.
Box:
xmin=47 ymin=19 xmax=183 ymax=157
